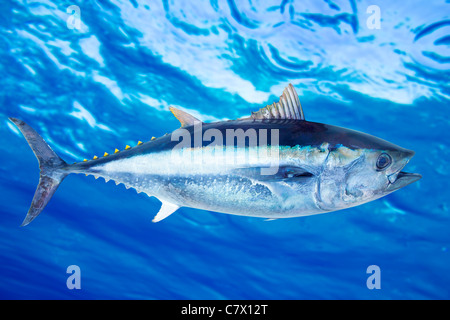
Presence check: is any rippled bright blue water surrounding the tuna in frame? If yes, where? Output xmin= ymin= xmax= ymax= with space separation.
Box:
xmin=0 ymin=0 xmax=450 ymax=299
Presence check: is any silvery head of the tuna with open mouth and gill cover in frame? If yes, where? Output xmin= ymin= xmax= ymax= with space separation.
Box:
xmin=319 ymin=128 xmax=422 ymax=210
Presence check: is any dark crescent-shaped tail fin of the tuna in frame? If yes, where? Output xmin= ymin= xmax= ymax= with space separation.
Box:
xmin=9 ymin=118 xmax=68 ymax=226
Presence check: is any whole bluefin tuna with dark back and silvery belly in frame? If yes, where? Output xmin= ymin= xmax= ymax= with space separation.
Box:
xmin=10 ymin=85 xmax=421 ymax=226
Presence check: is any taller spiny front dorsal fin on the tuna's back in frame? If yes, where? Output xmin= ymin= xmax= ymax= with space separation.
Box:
xmin=251 ymin=84 xmax=305 ymax=120
